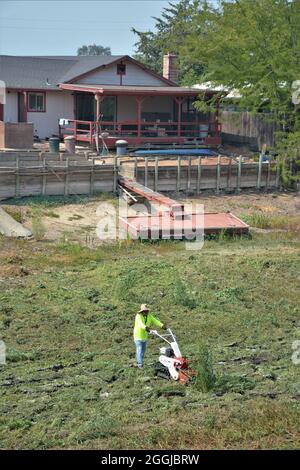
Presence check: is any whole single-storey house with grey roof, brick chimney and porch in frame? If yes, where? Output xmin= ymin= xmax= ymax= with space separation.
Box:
xmin=0 ymin=54 xmax=221 ymax=147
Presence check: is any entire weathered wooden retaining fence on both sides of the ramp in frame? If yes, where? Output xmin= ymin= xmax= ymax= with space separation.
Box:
xmin=0 ymin=152 xmax=280 ymax=200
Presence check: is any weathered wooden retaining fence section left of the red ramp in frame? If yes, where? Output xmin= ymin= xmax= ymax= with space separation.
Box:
xmin=0 ymin=152 xmax=118 ymax=200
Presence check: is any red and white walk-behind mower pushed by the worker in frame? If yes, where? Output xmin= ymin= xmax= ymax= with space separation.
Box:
xmin=150 ymin=328 xmax=196 ymax=384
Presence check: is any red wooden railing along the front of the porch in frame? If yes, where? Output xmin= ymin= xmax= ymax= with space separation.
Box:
xmin=60 ymin=119 xmax=221 ymax=144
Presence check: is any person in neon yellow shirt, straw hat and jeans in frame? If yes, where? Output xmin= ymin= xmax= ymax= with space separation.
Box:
xmin=133 ymin=304 xmax=167 ymax=369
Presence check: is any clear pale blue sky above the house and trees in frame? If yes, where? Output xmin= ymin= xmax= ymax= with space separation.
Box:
xmin=0 ymin=0 xmax=171 ymax=55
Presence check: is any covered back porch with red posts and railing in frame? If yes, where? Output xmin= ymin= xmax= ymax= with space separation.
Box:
xmin=60 ymin=84 xmax=221 ymax=148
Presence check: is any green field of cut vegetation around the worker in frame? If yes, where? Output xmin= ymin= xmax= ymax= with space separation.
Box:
xmin=0 ymin=192 xmax=300 ymax=449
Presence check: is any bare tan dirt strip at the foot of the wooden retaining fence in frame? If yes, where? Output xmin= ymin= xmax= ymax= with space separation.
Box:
xmin=3 ymin=189 xmax=300 ymax=247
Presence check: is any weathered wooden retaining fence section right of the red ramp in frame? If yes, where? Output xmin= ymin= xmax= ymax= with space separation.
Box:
xmin=120 ymin=157 xmax=280 ymax=194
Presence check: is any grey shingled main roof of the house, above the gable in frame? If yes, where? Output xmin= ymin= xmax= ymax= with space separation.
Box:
xmin=0 ymin=55 xmax=174 ymax=90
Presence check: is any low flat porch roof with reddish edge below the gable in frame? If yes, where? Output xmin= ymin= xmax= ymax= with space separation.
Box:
xmin=59 ymin=83 xmax=203 ymax=96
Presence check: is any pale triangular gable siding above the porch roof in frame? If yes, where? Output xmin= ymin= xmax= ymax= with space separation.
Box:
xmin=79 ymin=61 xmax=166 ymax=86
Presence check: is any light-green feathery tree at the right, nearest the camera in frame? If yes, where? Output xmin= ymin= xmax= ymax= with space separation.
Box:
xmin=180 ymin=0 xmax=300 ymax=125
